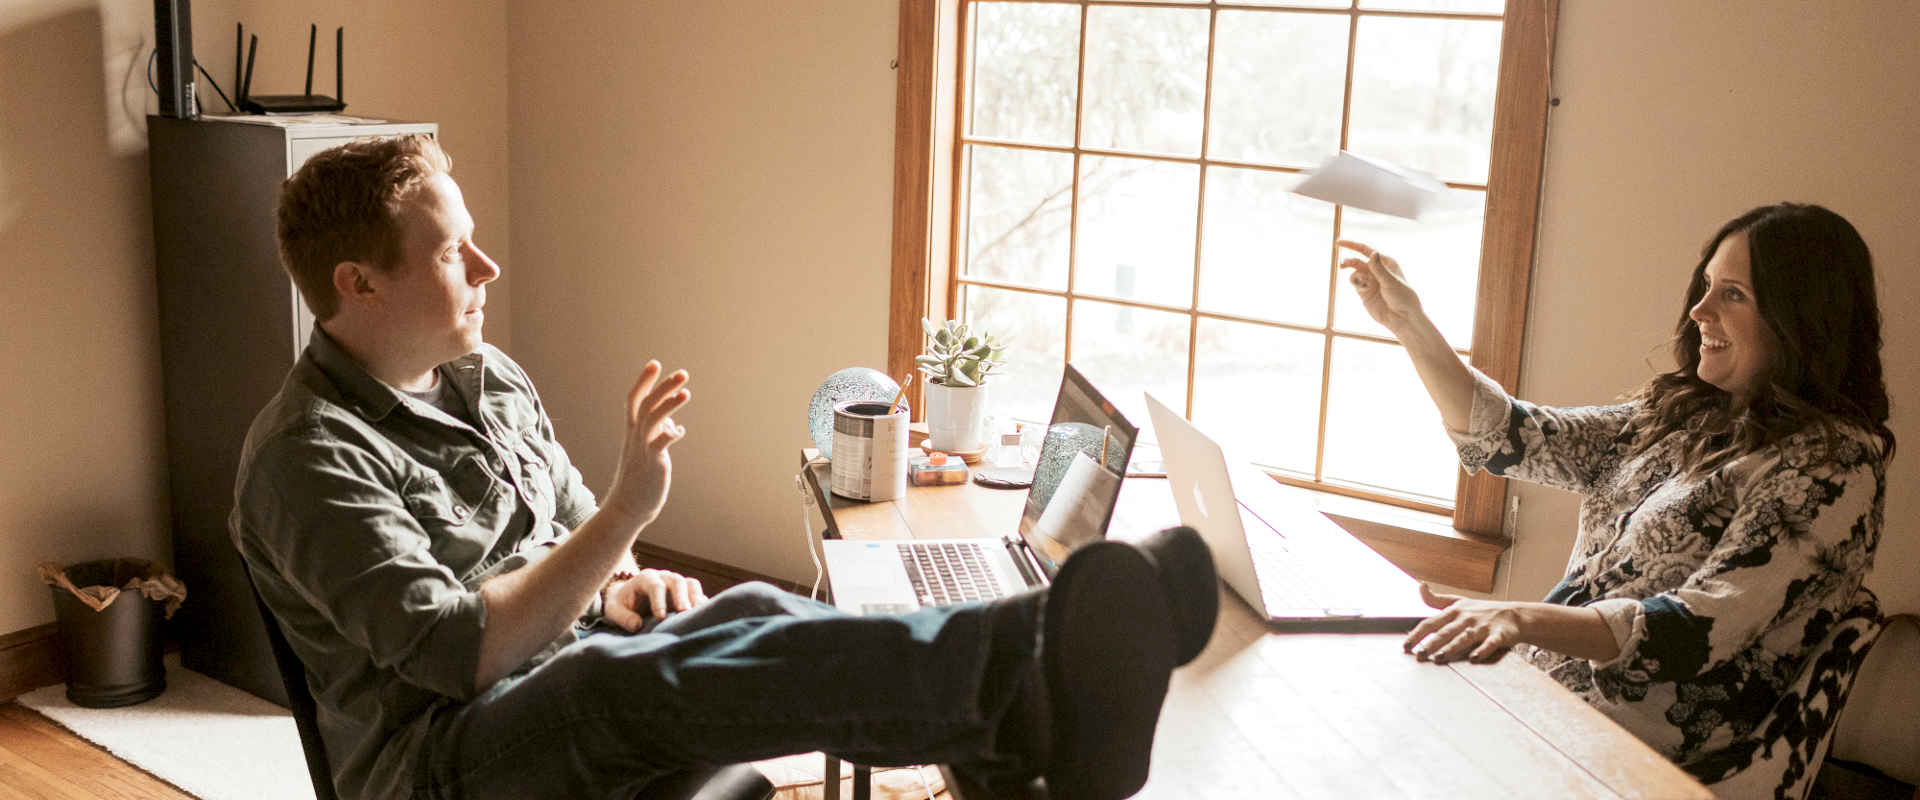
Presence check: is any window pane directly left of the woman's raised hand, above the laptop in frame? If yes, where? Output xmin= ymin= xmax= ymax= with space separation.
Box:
xmin=1175 ymin=318 xmax=1327 ymax=478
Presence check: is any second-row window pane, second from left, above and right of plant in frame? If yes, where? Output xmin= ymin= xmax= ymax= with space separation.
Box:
xmin=1073 ymin=155 xmax=1200 ymax=307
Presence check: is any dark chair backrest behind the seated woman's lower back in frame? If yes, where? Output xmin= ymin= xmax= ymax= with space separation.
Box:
xmin=1711 ymin=589 xmax=1885 ymax=800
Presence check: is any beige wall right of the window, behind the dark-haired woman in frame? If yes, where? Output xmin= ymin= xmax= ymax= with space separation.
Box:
xmin=1511 ymin=0 xmax=1920 ymax=612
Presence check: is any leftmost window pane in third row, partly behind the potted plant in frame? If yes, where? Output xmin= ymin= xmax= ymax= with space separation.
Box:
xmin=960 ymin=286 xmax=1068 ymax=428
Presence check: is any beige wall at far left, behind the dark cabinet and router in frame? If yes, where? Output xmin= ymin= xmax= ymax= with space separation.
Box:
xmin=0 ymin=0 xmax=511 ymax=633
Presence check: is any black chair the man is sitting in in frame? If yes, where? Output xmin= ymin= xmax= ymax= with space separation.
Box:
xmin=246 ymin=570 xmax=774 ymax=800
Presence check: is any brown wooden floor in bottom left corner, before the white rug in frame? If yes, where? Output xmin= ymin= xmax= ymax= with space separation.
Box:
xmin=0 ymin=702 xmax=192 ymax=800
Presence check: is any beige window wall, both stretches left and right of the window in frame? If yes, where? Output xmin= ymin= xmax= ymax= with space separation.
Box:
xmin=511 ymin=0 xmax=1920 ymax=610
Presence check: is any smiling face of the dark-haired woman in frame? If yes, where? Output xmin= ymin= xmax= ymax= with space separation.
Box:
xmin=1688 ymin=232 xmax=1776 ymax=407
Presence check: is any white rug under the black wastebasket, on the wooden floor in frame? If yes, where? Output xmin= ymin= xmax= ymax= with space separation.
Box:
xmin=19 ymin=654 xmax=313 ymax=800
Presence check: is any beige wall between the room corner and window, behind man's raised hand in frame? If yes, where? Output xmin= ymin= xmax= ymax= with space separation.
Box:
xmin=511 ymin=0 xmax=899 ymax=581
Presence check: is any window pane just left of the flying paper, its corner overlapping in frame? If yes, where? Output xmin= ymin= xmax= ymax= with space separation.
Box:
xmin=1200 ymin=167 xmax=1332 ymax=328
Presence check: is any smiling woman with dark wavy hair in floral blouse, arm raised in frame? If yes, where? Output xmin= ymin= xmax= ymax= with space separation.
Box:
xmin=1342 ymin=203 xmax=1893 ymax=788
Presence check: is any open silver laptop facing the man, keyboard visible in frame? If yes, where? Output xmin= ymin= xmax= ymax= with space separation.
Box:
xmin=820 ymin=365 xmax=1140 ymax=614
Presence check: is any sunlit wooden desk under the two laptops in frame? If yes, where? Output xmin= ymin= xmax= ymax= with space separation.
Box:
xmin=803 ymin=453 xmax=1713 ymax=800
